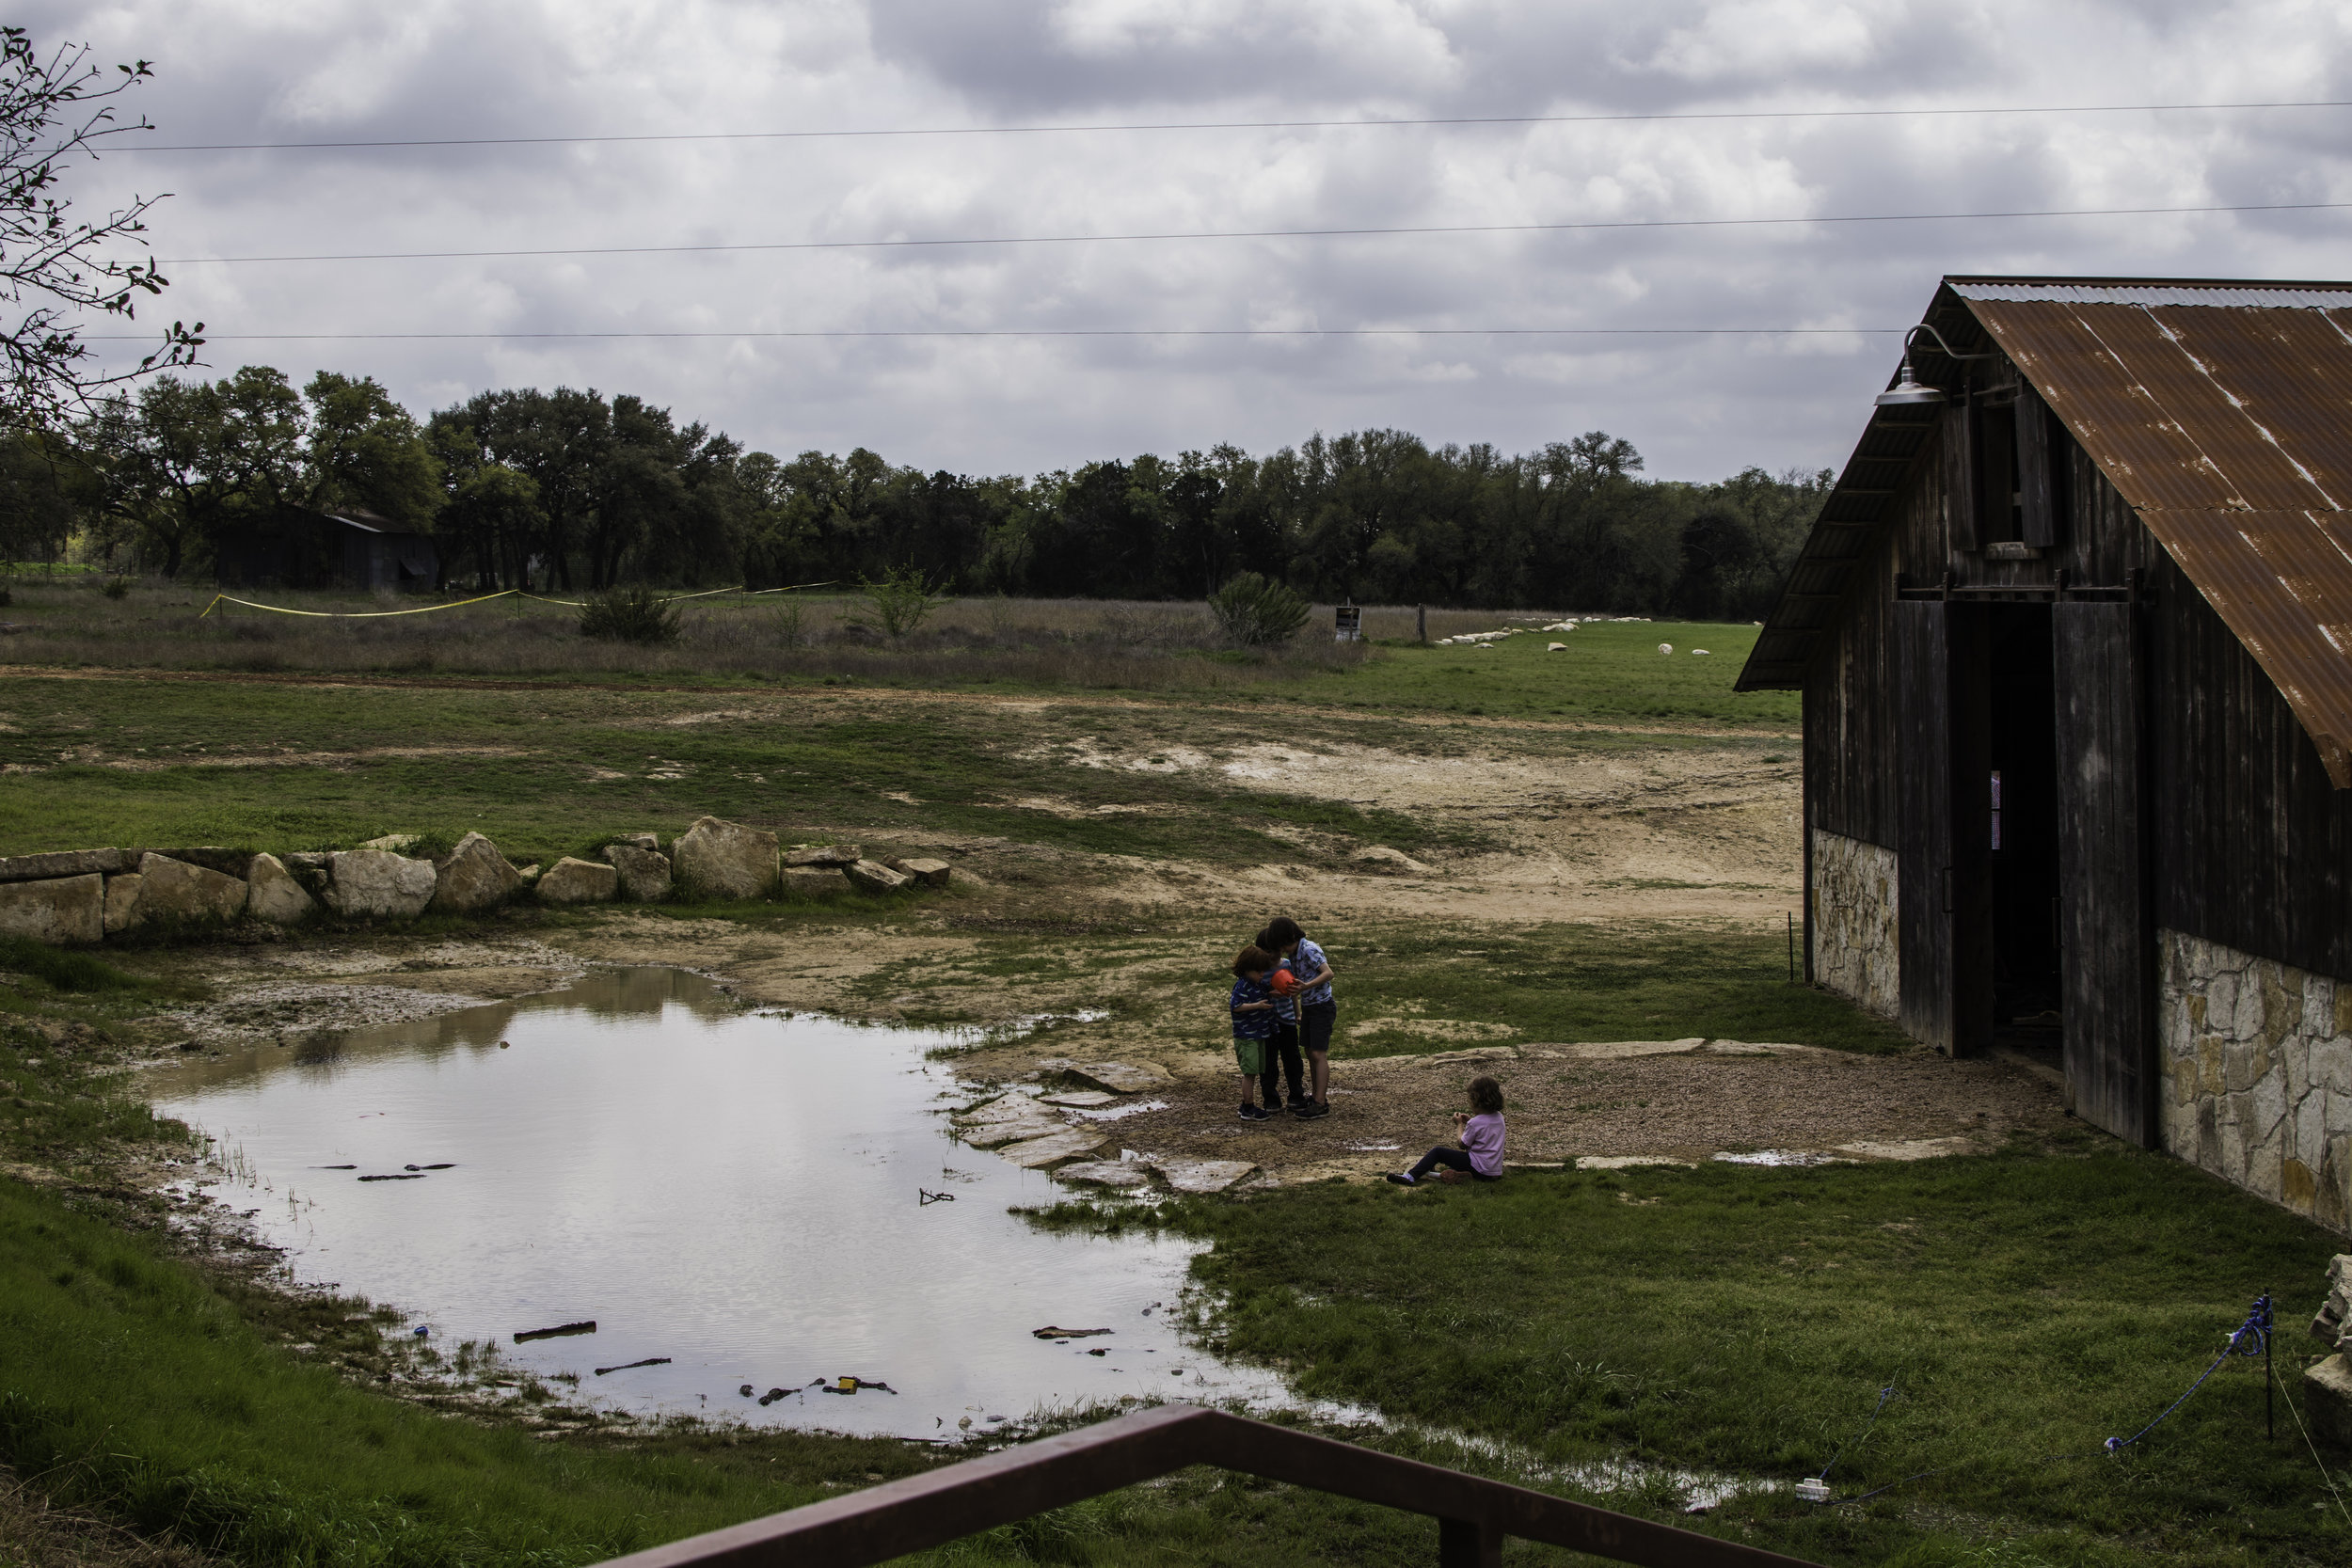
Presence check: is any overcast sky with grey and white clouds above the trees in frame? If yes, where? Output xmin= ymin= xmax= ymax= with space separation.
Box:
xmin=45 ymin=0 xmax=2352 ymax=480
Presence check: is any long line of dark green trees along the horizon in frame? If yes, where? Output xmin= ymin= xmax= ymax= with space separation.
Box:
xmin=0 ymin=364 xmax=1830 ymax=621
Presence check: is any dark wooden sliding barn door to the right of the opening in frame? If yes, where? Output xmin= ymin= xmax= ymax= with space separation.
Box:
xmin=2054 ymin=604 xmax=2157 ymax=1148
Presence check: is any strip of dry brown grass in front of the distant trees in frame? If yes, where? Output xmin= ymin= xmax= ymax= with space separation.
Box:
xmin=0 ymin=580 xmax=1609 ymax=691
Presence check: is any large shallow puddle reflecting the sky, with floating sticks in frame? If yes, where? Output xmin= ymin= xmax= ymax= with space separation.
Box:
xmin=149 ymin=969 xmax=1294 ymax=1439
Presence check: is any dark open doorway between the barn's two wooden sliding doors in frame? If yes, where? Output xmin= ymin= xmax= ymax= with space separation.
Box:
xmin=1983 ymin=604 xmax=2065 ymax=1068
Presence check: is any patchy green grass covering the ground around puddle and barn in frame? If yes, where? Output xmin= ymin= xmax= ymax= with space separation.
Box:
xmin=0 ymin=588 xmax=2352 ymax=1568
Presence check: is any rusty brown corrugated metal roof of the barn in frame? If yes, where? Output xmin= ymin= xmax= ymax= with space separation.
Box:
xmin=1740 ymin=277 xmax=2352 ymax=790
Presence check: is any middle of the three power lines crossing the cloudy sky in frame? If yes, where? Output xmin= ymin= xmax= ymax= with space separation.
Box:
xmin=158 ymin=202 xmax=2352 ymax=265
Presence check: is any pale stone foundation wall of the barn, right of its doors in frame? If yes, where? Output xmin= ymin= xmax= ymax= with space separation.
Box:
xmin=2157 ymin=931 xmax=2352 ymax=1232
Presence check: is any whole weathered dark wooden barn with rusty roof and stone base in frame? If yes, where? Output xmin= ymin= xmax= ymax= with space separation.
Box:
xmin=1740 ymin=277 xmax=2352 ymax=1229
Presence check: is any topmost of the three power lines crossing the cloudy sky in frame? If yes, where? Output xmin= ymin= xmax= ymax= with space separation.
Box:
xmin=113 ymin=99 xmax=2352 ymax=152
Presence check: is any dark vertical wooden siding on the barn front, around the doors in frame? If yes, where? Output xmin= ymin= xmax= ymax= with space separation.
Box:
xmin=1802 ymin=328 xmax=2352 ymax=1053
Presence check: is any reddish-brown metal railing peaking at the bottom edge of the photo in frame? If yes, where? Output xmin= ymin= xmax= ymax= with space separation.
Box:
xmin=605 ymin=1406 xmax=1814 ymax=1568
